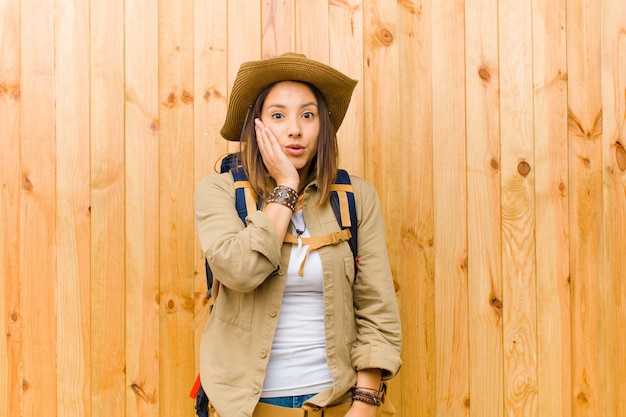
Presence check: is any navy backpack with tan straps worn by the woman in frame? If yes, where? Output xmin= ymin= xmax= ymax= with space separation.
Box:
xmin=189 ymin=152 xmax=359 ymax=417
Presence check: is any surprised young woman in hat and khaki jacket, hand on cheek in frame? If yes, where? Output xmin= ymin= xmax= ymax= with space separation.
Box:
xmin=195 ymin=53 xmax=402 ymax=417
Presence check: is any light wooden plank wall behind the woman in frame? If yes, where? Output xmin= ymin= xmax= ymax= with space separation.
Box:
xmin=0 ymin=0 xmax=626 ymax=417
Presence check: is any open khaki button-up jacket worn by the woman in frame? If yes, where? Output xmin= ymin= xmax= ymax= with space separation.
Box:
xmin=195 ymin=173 xmax=402 ymax=417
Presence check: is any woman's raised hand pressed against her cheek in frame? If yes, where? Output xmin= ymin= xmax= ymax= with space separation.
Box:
xmin=254 ymin=118 xmax=300 ymax=191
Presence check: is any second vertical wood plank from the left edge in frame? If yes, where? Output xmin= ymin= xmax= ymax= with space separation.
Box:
xmin=19 ymin=0 xmax=58 ymax=417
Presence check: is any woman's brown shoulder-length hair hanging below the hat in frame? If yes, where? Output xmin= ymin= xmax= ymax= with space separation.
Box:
xmin=241 ymin=81 xmax=338 ymax=206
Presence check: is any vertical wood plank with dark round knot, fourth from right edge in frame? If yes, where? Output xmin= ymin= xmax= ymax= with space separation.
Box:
xmin=498 ymin=0 xmax=538 ymax=416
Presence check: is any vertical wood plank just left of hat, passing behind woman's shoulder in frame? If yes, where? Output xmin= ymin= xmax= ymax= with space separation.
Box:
xmin=193 ymin=0 xmax=228 ymax=373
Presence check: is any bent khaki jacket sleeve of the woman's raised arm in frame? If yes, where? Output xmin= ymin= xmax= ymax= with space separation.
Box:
xmin=194 ymin=173 xmax=281 ymax=292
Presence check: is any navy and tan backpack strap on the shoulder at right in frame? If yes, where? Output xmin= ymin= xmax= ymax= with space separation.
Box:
xmin=330 ymin=169 xmax=359 ymax=267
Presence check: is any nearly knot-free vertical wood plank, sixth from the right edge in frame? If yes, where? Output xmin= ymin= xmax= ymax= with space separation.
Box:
xmin=432 ymin=1 xmax=469 ymax=416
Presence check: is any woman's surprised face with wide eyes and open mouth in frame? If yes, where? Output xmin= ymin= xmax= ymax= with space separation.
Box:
xmin=261 ymin=81 xmax=320 ymax=174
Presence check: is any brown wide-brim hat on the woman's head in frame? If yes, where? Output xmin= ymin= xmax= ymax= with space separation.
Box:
xmin=220 ymin=53 xmax=357 ymax=141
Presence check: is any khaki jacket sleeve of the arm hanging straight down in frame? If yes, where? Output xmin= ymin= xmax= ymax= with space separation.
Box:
xmin=352 ymin=177 xmax=402 ymax=379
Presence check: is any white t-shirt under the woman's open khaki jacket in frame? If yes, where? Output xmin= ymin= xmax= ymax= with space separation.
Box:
xmin=261 ymin=211 xmax=332 ymax=398
